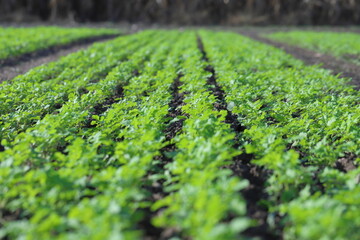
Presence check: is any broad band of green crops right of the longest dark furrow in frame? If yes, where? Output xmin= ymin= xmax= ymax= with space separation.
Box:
xmin=201 ymin=31 xmax=360 ymax=239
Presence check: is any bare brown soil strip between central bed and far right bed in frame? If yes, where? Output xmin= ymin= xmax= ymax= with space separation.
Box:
xmin=240 ymin=31 xmax=360 ymax=90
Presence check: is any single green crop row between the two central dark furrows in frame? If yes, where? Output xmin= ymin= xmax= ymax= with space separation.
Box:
xmin=152 ymin=33 xmax=251 ymax=239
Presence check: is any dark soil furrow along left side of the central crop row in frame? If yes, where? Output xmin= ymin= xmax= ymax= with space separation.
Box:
xmin=139 ymin=74 xmax=184 ymax=240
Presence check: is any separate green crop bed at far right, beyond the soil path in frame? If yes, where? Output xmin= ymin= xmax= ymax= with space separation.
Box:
xmin=267 ymin=31 xmax=360 ymax=64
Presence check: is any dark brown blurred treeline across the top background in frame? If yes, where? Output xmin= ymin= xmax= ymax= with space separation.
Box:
xmin=0 ymin=0 xmax=360 ymax=25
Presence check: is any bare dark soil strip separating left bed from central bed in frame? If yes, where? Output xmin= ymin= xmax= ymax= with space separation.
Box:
xmin=0 ymin=35 xmax=119 ymax=83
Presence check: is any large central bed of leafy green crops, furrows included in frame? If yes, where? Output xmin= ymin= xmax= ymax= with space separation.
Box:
xmin=0 ymin=30 xmax=360 ymax=240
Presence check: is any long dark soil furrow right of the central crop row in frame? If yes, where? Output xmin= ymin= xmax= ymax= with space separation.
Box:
xmin=198 ymin=37 xmax=282 ymax=240
